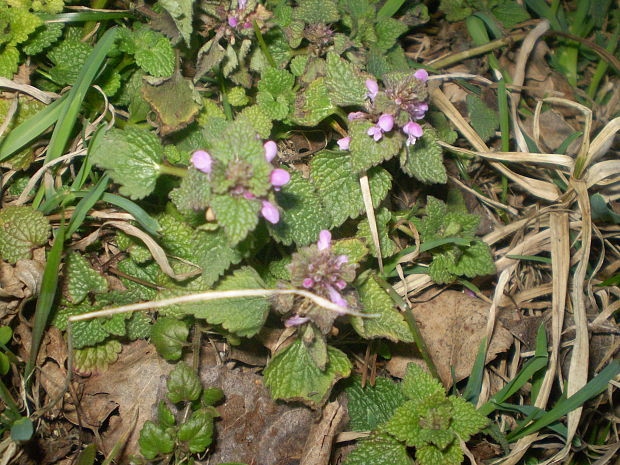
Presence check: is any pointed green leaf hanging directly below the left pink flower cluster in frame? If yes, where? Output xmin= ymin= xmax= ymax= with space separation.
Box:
xmin=211 ymin=195 xmax=261 ymax=245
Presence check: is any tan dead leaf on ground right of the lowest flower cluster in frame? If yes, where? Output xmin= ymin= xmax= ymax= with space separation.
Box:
xmin=387 ymin=291 xmax=513 ymax=387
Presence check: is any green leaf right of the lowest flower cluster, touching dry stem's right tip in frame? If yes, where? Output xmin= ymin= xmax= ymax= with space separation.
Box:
xmin=351 ymin=275 xmax=413 ymax=342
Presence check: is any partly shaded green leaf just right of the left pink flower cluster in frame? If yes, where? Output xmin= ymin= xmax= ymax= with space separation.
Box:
xmin=269 ymin=171 xmax=332 ymax=246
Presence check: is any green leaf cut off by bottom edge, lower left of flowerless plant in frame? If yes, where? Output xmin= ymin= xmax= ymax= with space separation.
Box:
xmin=343 ymin=434 xmax=414 ymax=465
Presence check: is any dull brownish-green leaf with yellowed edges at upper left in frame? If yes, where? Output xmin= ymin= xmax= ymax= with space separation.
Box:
xmin=142 ymin=73 xmax=200 ymax=136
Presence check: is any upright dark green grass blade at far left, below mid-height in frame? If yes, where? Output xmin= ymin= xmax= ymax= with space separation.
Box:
xmin=24 ymin=224 xmax=65 ymax=386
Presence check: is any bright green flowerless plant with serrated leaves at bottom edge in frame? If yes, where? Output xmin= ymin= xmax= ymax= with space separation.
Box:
xmin=345 ymin=364 xmax=488 ymax=465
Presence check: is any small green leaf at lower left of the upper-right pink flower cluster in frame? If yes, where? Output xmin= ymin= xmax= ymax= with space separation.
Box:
xmin=349 ymin=121 xmax=404 ymax=173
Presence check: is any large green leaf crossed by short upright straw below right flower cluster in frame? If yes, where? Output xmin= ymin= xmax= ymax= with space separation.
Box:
xmin=310 ymin=150 xmax=392 ymax=229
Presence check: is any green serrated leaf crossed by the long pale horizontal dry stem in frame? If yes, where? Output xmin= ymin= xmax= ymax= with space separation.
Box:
xmin=193 ymin=267 xmax=269 ymax=337
